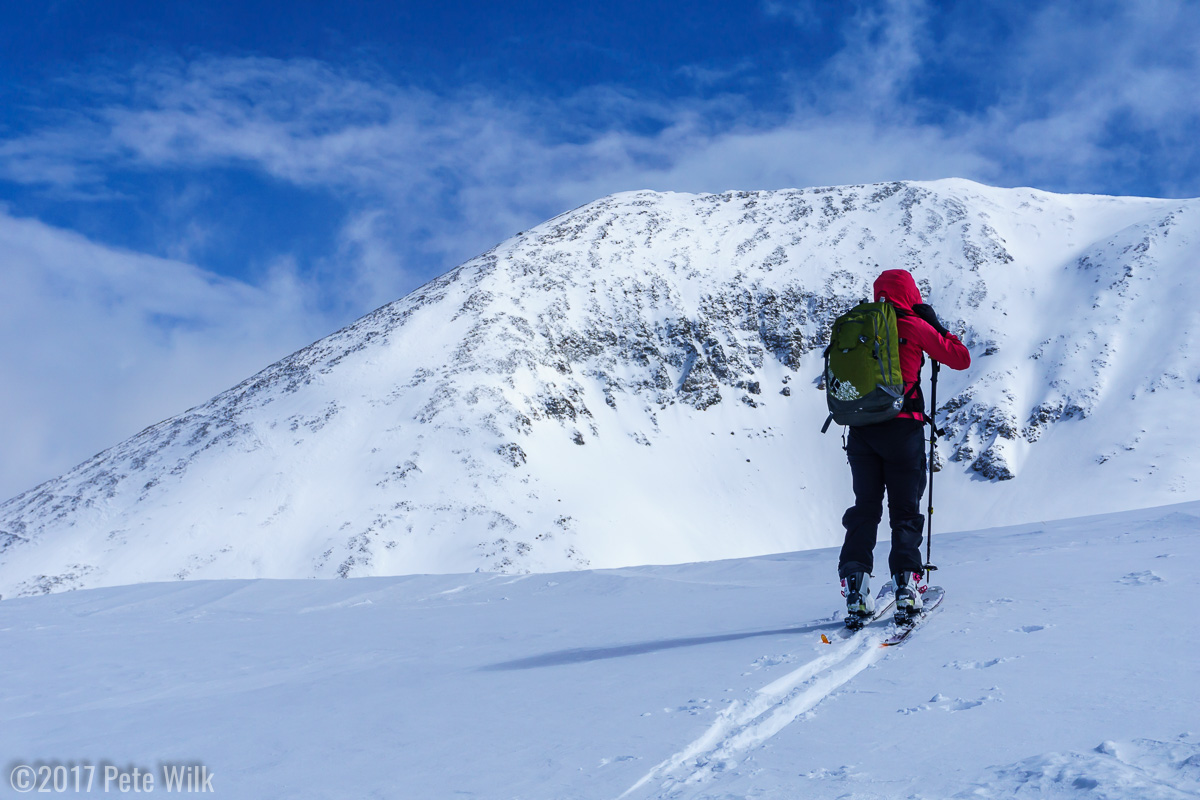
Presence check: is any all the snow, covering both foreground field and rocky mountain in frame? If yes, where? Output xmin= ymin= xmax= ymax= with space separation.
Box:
xmin=0 ymin=180 xmax=1200 ymax=800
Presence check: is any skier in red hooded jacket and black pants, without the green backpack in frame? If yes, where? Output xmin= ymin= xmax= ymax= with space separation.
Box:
xmin=838 ymin=270 xmax=971 ymax=621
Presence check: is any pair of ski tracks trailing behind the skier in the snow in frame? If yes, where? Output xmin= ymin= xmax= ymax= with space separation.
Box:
xmin=618 ymin=630 xmax=887 ymax=800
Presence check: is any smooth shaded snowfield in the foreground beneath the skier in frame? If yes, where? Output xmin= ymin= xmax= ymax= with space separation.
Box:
xmin=0 ymin=503 xmax=1200 ymax=800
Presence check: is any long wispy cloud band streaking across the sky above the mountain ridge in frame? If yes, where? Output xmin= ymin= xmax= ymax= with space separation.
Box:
xmin=0 ymin=0 xmax=1200 ymax=257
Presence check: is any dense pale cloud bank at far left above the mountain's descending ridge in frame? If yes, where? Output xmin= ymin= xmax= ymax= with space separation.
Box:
xmin=0 ymin=213 xmax=328 ymax=498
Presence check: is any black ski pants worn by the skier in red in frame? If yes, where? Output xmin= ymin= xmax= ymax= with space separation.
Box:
xmin=838 ymin=419 xmax=926 ymax=578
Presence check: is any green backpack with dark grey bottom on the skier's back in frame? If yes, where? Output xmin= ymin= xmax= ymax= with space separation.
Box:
xmin=821 ymin=302 xmax=905 ymax=433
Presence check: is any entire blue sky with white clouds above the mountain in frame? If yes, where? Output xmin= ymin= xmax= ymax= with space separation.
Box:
xmin=0 ymin=0 xmax=1200 ymax=497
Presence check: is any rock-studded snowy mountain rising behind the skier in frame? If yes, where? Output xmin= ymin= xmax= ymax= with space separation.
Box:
xmin=0 ymin=180 xmax=1200 ymax=596
